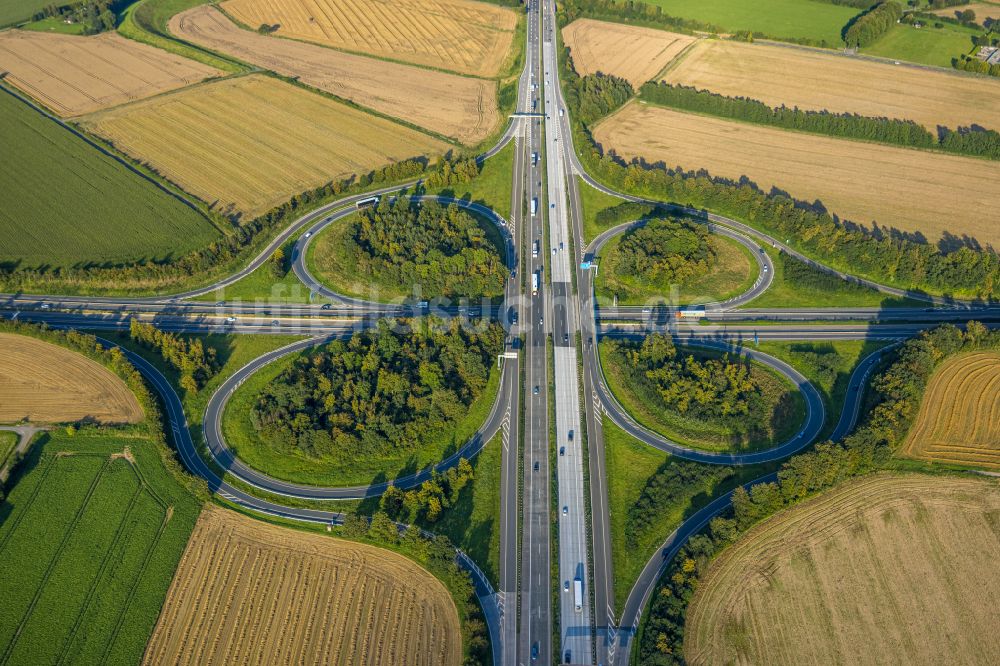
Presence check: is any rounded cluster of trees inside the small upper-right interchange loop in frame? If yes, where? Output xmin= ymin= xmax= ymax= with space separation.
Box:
xmin=616 ymin=219 xmax=716 ymax=283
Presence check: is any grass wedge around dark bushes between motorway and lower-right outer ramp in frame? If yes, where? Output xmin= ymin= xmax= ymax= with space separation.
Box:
xmin=602 ymin=416 xmax=776 ymax=611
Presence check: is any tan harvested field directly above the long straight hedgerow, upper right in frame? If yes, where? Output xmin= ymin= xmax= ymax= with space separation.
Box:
xmin=664 ymin=40 xmax=1000 ymax=133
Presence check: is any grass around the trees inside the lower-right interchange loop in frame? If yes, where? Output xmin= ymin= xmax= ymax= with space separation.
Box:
xmin=598 ymin=341 xmax=805 ymax=452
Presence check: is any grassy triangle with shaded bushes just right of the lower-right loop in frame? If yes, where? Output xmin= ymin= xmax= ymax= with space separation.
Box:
xmin=756 ymin=340 xmax=889 ymax=441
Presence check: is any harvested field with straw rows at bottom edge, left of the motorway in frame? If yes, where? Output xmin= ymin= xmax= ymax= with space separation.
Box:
xmin=144 ymin=505 xmax=462 ymax=665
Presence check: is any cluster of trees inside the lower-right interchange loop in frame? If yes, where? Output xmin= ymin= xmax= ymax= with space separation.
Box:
xmin=610 ymin=333 xmax=766 ymax=422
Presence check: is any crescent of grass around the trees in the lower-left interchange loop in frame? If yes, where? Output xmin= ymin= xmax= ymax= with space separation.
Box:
xmin=219 ymin=344 xmax=500 ymax=486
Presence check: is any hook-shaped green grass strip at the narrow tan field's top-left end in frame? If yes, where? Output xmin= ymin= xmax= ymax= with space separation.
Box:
xmin=118 ymin=0 xmax=247 ymax=74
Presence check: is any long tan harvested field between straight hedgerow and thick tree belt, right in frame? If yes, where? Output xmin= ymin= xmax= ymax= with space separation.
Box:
xmin=594 ymin=103 xmax=1000 ymax=247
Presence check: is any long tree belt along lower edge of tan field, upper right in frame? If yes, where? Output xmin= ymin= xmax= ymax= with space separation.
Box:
xmin=575 ymin=148 xmax=1000 ymax=299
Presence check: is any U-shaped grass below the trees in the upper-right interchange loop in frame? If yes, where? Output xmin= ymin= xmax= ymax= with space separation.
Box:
xmin=594 ymin=227 xmax=757 ymax=305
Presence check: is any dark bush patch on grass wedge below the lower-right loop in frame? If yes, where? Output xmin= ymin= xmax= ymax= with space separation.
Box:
xmin=625 ymin=460 xmax=735 ymax=549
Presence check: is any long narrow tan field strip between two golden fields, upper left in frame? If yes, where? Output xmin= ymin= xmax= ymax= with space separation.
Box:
xmin=170 ymin=5 xmax=500 ymax=144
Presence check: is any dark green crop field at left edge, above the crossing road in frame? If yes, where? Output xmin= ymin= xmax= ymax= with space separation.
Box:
xmin=0 ymin=90 xmax=219 ymax=268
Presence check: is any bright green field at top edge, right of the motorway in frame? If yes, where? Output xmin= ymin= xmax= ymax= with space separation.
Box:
xmin=647 ymin=0 xmax=860 ymax=46
